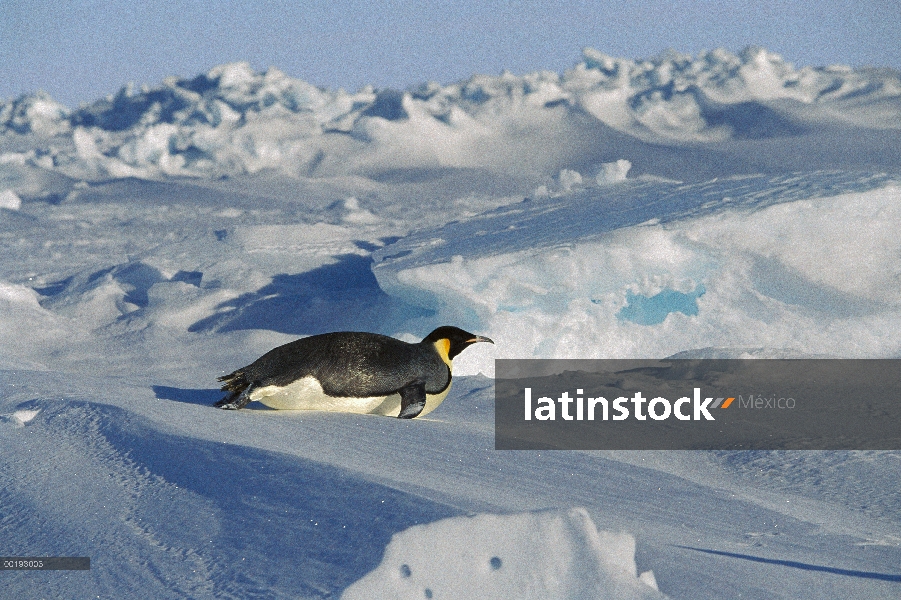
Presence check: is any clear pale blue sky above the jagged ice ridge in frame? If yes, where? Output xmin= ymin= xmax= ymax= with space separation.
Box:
xmin=0 ymin=0 xmax=901 ymax=107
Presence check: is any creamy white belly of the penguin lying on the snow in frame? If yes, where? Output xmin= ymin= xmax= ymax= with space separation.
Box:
xmin=250 ymin=375 xmax=450 ymax=417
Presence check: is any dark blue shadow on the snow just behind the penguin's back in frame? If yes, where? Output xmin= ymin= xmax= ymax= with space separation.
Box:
xmin=188 ymin=254 xmax=433 ymax=335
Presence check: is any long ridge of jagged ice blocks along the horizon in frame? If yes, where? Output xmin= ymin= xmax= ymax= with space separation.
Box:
xmin=0 ymin=48 xmax=901 ymax=180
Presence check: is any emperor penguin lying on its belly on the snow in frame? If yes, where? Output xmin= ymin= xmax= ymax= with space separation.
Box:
xmin=214 ymin=326 xmax=494 ymax=419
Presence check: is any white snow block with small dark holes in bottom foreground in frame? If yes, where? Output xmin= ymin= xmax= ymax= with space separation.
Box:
xmin=341 ymin=508 xmax=665 ymax=600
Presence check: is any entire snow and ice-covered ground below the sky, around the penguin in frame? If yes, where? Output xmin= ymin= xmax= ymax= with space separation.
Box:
xmin=0 ymin=49 xmax=901 ymax=598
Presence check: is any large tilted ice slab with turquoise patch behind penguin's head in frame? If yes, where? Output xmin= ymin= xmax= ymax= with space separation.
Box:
xmin=373 ymin=173 xmax=901 ymax=376
